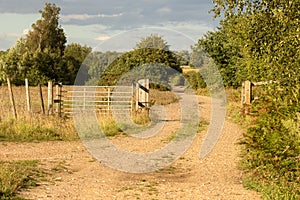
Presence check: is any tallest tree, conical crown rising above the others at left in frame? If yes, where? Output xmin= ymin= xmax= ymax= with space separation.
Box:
xmin=26 ymin=3 xmax=67 ymax=56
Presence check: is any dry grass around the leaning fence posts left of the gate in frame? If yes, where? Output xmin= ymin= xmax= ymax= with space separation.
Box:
xmin=0 ymin=86 xmax=78 ymax=142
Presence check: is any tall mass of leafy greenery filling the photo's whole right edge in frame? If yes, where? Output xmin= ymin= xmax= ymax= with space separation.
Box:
xmin=213 ymin=0 xmax=300 ymax=199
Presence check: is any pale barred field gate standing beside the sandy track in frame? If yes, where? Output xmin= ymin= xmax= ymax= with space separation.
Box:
xmin=61 ymin=85 xmax=134 ymax=114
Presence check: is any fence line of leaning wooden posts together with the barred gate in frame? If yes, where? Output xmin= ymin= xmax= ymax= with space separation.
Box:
xmin=0 ymin=80 xmax=149 ymax=120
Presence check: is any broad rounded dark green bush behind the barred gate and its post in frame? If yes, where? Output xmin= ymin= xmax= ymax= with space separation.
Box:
xmin=98 ymin=48 xmax=182 ymax=85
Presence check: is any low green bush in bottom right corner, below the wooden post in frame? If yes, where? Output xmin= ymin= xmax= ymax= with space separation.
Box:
xmin=242 ymin=113 xmax=300 ymax=199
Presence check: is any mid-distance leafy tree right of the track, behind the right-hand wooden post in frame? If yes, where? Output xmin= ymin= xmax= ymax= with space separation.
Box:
xmin=199 ymin=18 xmax=247 ymax=87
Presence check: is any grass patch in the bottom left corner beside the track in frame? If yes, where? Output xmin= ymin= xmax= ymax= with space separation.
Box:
xmin=0 ymin=161 xmax=41 ymax=199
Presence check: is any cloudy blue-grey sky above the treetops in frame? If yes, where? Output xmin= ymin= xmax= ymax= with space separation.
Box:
xmin=0 ymin=0 xmax=218 ymax=51
